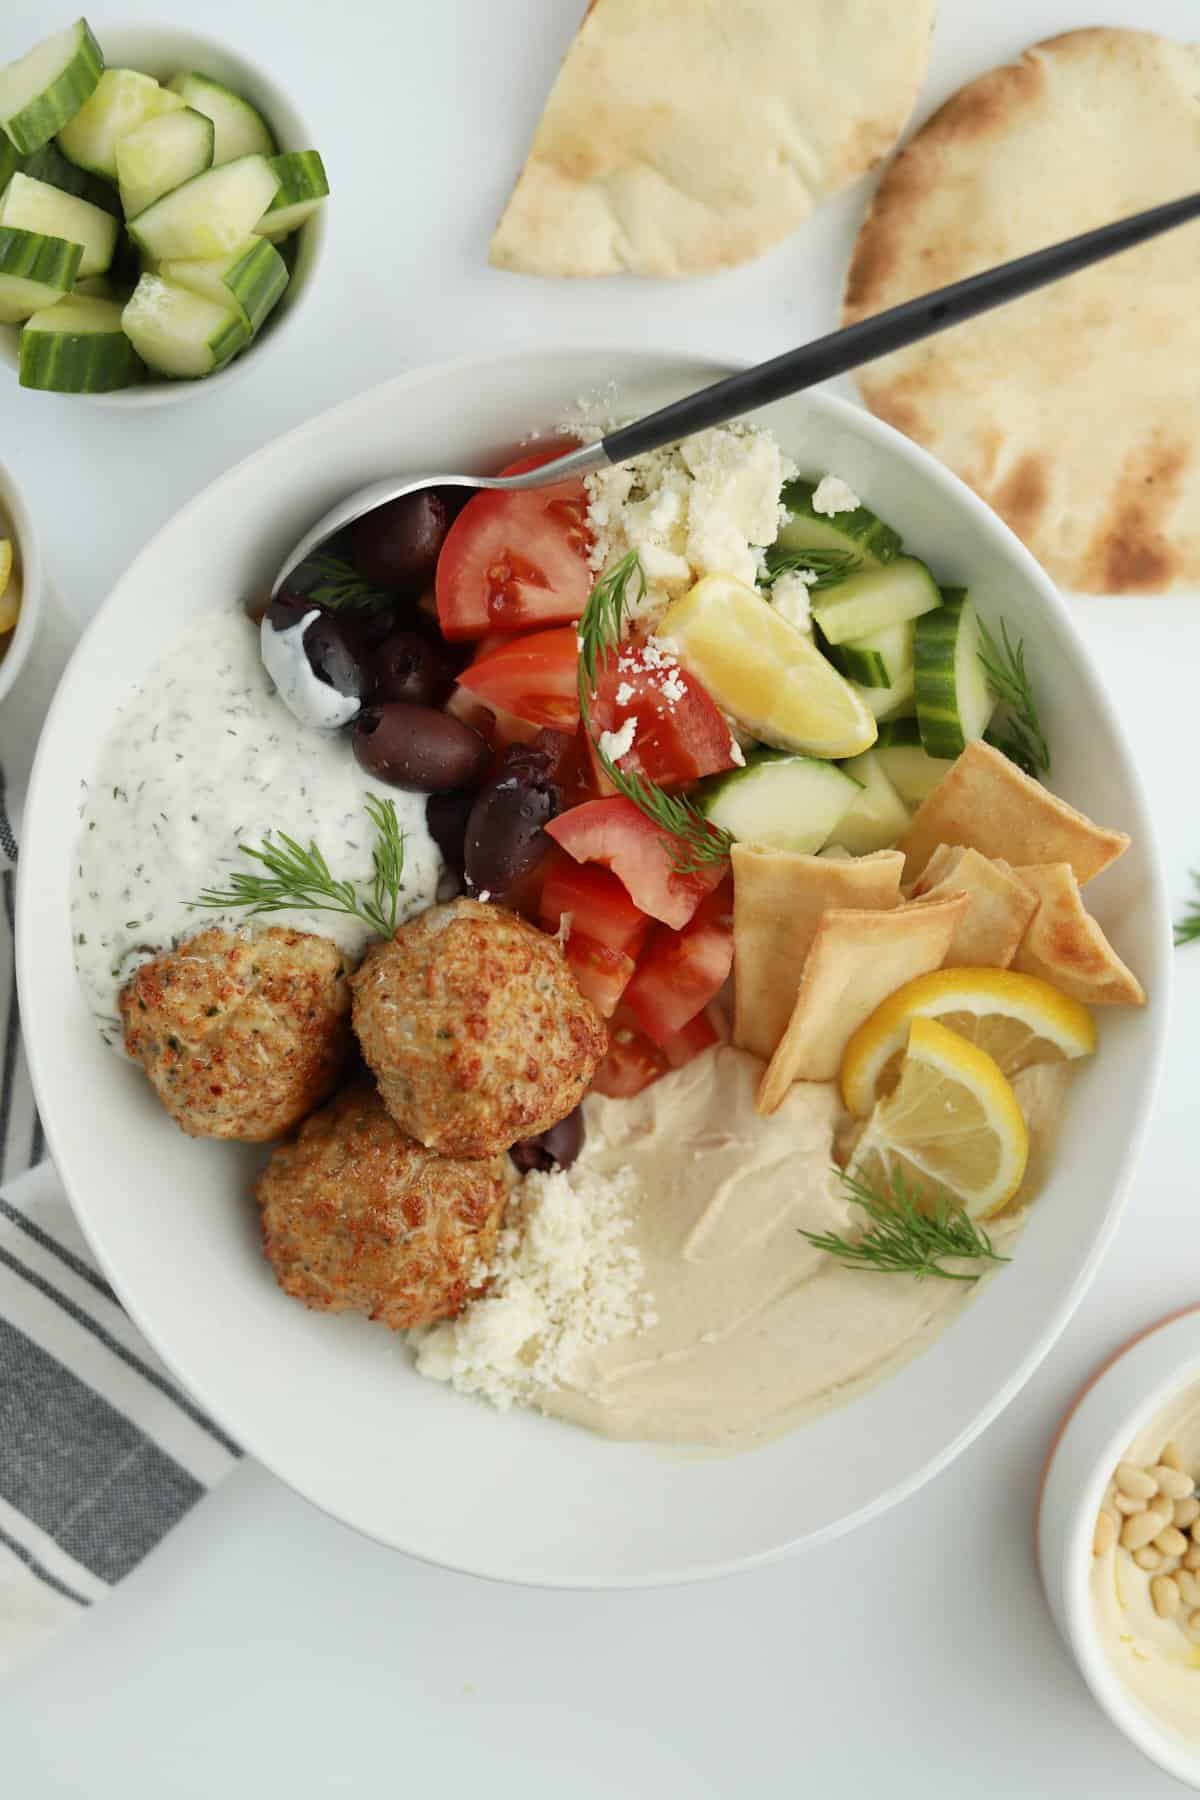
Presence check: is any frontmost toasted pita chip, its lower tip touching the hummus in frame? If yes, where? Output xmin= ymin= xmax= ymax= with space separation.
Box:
xmin=754 ymin=895 xmax=968 ymax=1112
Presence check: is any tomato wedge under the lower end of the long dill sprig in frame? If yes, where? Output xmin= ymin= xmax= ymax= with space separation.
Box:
xmin=547 ymin=794 xmax=729 ymax=931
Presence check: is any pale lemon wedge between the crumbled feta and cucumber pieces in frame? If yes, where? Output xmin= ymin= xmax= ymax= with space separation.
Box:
xmin=658 ymin=574 xmax=878 ymax=758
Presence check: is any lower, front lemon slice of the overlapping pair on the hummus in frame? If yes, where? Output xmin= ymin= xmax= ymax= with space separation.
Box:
xmin=853 ymin=1019 xmax=1029 ymax=1219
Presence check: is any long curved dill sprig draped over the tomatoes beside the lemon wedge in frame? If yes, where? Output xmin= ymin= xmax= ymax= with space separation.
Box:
xmin=578 ymin=551 xmax=732 ymax=875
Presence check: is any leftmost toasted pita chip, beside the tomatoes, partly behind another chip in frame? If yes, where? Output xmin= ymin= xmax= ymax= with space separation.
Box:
xmin=732 ymin=844 xmax=905 ymax=1060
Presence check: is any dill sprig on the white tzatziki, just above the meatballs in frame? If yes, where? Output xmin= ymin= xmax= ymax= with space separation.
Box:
xmin=191 ymin=794 xmax=405 ymax=938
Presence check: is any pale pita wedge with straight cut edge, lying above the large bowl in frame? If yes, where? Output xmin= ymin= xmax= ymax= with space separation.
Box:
xmin=489 ymin=0 xmax=936 ymax=275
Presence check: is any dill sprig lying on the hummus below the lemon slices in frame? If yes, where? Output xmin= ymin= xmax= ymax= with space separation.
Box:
xmin=801 ymin=1168 xmax=1009 ymax=1282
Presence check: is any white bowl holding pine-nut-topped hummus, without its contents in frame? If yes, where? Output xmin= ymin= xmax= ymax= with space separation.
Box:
xmin=1038 ymin=1307 xmax=1200 ymax=1787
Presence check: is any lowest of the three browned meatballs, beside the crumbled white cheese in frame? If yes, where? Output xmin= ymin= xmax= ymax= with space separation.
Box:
xmin=254 ymin=1082 xmax=506 ymax=1332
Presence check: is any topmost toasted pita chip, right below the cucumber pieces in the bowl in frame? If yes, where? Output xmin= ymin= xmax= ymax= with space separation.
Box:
xmin=900 ymin=738 xmax=1130 ymax=882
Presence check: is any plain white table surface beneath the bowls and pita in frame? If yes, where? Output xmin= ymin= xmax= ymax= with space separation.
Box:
xmin=0 ymin=0 xmax=1200 ymax=1800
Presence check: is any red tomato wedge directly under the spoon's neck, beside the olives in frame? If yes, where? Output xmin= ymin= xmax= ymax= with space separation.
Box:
xmin=435 ymin=443 xmax=594 ymax=639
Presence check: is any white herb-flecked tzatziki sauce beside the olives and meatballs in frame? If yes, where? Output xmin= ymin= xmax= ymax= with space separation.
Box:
xmin=70 ymin=605 xmax=443 ymax=1049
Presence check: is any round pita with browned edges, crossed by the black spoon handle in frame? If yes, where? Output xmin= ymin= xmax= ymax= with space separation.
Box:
xmin=844 ymin=27 xmax=1200 ymax=594
